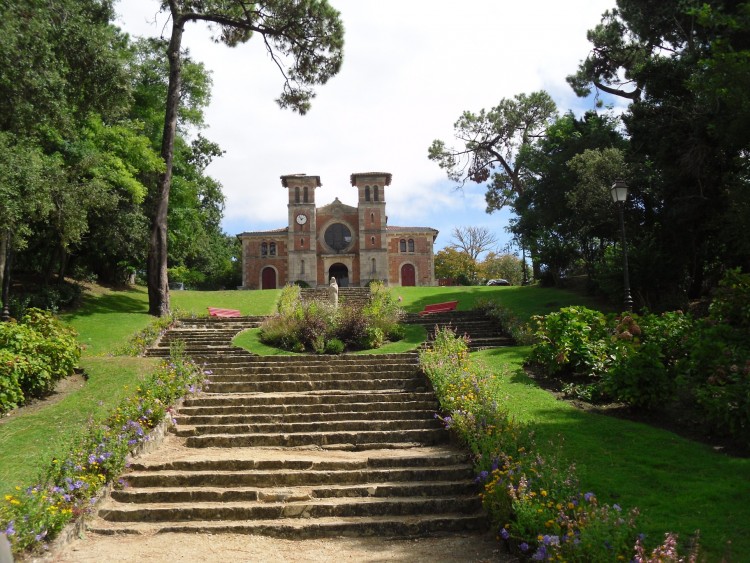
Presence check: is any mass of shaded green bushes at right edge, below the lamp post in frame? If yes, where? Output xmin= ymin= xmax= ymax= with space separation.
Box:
xmin=528 ymin=271 xmax=750 ymax=447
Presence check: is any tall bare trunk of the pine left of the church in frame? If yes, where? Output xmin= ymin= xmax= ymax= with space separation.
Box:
xmin=147 ymin=11 xmax=185 ymax=317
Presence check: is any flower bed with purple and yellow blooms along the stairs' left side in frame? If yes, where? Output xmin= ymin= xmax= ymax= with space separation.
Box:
xmin=0 ymin=347 xmax=204 ymax=553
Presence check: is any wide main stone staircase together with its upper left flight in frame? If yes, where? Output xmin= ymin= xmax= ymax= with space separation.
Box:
xmin=89 ymin=334 xmax=486 ymax=539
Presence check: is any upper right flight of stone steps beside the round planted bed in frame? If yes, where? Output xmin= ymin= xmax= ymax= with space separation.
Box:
xmin=404 ymin=311 xmax=514 ymax=350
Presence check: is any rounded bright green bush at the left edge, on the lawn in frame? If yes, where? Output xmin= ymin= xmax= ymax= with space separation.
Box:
xmin=0 ymin=308 xmax=81 ymax=412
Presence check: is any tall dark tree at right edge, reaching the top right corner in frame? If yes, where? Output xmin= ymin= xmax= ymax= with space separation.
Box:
xmin=568 ymin=0 xmax=750 ymax=306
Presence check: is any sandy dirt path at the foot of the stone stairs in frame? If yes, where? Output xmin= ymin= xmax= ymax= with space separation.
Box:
xmin=44 ymin=534 xmax=516 ymax=563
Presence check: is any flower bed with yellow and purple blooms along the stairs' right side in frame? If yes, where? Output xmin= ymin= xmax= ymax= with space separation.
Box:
xmin=420 ymin=329 xmax=696 ymax=561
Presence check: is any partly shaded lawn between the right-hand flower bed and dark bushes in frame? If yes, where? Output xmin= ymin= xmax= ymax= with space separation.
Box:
xmin=474 ymin=348 xmax=750 ymax=561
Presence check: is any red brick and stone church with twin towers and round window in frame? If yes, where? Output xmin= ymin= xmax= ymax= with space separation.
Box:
xmin=237 ymin=172 xmax=438 ymax=289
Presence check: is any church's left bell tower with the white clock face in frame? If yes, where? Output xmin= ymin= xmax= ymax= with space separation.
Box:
xmin=281 ymin=174 xmax=321 ymax=287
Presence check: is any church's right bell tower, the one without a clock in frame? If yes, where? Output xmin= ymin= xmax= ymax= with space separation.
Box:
xmin=350 ymin=172 xmax=391 ymax=286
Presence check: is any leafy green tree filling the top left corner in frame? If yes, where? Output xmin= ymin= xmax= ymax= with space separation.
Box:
xmin=0 ymin=0 xmax=134 ymax=300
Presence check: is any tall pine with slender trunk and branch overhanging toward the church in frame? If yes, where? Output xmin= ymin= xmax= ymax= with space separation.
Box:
xmin=148 ymin=0 xmax=344 ymax=316
